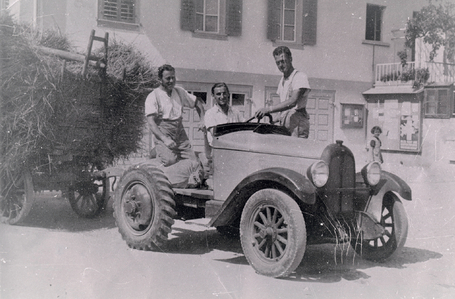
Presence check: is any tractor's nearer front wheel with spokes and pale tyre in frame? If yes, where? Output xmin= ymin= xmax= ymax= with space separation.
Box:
xmin=240 ymin=189 xmax=307 ymax=277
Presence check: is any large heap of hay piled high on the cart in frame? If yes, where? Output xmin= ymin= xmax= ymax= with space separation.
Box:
xmin=0 ymin=16 xmax=157 ymax=181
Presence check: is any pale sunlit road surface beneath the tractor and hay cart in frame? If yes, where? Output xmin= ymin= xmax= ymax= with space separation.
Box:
xmin=0 ymin=178 xmax=455 ymax=299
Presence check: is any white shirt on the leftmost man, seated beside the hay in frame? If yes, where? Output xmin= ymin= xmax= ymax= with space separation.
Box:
xmin=145 ymin=86 xmax=196 ymax=120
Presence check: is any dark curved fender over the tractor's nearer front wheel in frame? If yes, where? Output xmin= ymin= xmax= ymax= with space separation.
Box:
xmin=209 ymin=167 xmax=316 ymax=226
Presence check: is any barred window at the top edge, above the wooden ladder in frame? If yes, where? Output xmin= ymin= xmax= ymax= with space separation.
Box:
xmin=98 ymin=0 xmax=139 ymax=29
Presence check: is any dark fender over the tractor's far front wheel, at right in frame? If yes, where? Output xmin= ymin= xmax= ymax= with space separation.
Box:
xmin=365 ymin=171 xmax=412 ymax=222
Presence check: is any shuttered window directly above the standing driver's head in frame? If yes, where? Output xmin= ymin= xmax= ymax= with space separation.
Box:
xmin=267 ymin=0 xmax=317 ymax=48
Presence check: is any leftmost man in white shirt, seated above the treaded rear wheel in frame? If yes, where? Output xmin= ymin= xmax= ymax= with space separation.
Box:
xmin=145 ymin=64 xmax=205 ymax=186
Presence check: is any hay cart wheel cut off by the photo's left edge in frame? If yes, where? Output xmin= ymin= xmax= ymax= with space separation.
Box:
xmin=0 ymin=171 xmax=35 ymax=224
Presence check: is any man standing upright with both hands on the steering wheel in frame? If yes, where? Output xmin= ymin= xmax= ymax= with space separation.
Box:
xmin=255 ymin=46 xmax=311 ymax=138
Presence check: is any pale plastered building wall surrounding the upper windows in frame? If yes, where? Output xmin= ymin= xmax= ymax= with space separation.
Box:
xmin=9 ymin=0 xmax=451 ymax=170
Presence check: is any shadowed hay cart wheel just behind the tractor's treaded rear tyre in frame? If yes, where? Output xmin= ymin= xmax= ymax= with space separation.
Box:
xmin=68 ymin=180 xmax=107 ymax=218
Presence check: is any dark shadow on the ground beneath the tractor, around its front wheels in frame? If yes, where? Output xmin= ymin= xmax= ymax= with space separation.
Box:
xmin=149 ymin=227 xmax=443 ymax=283
